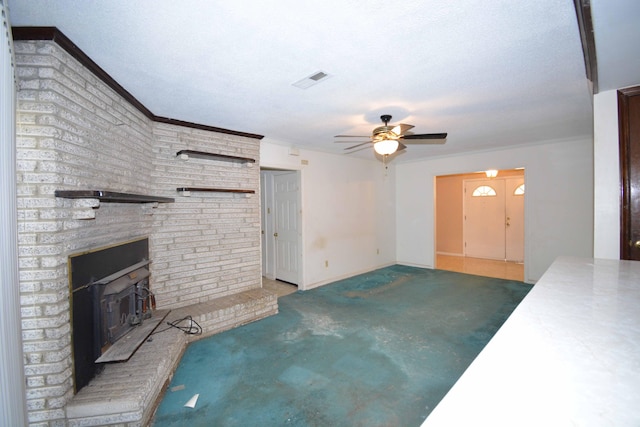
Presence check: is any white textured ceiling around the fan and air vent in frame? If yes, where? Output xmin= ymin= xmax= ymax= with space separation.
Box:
xmin=9 ymin=0 xmax=640 ymax=162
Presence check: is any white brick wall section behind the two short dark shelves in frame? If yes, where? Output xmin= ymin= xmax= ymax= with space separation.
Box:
xmin=151 ymin=123 xmax=261 ymax=307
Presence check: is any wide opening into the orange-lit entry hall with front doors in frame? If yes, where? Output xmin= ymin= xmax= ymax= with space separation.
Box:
xmin=435 ymin=169 xmax=525 ymax=281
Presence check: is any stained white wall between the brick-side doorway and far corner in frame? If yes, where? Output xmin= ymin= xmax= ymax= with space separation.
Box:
xmin=260 ymin=140 xmax=396 ymax=289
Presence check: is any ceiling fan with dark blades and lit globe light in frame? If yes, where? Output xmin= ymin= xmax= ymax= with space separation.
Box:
xmin=335 ymin=114 xmax=447 ymax=157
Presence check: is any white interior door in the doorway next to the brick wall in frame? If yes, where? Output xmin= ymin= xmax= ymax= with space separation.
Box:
xmin=274 ymin=172 xmax=301 ymax=285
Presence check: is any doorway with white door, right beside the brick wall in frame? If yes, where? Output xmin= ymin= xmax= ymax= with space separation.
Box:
xmin=260 ymin=169 xmax=302 ymax=286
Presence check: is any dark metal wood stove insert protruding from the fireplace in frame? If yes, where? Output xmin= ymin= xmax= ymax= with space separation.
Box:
xmin=99 ymin=267 xmax=153 ymax=352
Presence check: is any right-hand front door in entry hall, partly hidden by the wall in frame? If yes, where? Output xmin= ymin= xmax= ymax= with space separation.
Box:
xmin=505 ymin=177 xmax=524 ymax=262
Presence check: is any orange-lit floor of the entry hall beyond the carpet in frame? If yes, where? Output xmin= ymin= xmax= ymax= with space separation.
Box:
xmin=436 ymin=255 xmax=524 ymax=282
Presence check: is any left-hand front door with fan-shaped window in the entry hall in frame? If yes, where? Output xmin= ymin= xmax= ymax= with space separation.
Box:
xmin=463 ymin=179 xmax=505 ymax=260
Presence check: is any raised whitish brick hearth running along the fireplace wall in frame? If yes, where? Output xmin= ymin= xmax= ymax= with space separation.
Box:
xmin=66 ymin=289 xmax=278 ymax=427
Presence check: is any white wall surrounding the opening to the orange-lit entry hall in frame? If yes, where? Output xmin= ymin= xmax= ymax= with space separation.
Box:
xmin=396 ymin=137 xmax=593 ymax=283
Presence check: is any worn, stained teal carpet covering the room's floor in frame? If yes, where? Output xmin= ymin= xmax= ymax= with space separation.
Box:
xmin=153 ymin=265 xmax=531 ymax=427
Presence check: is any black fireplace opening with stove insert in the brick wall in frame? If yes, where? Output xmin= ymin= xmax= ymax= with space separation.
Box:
xmin=69 ymin=237 xmax=155 ymax=393
